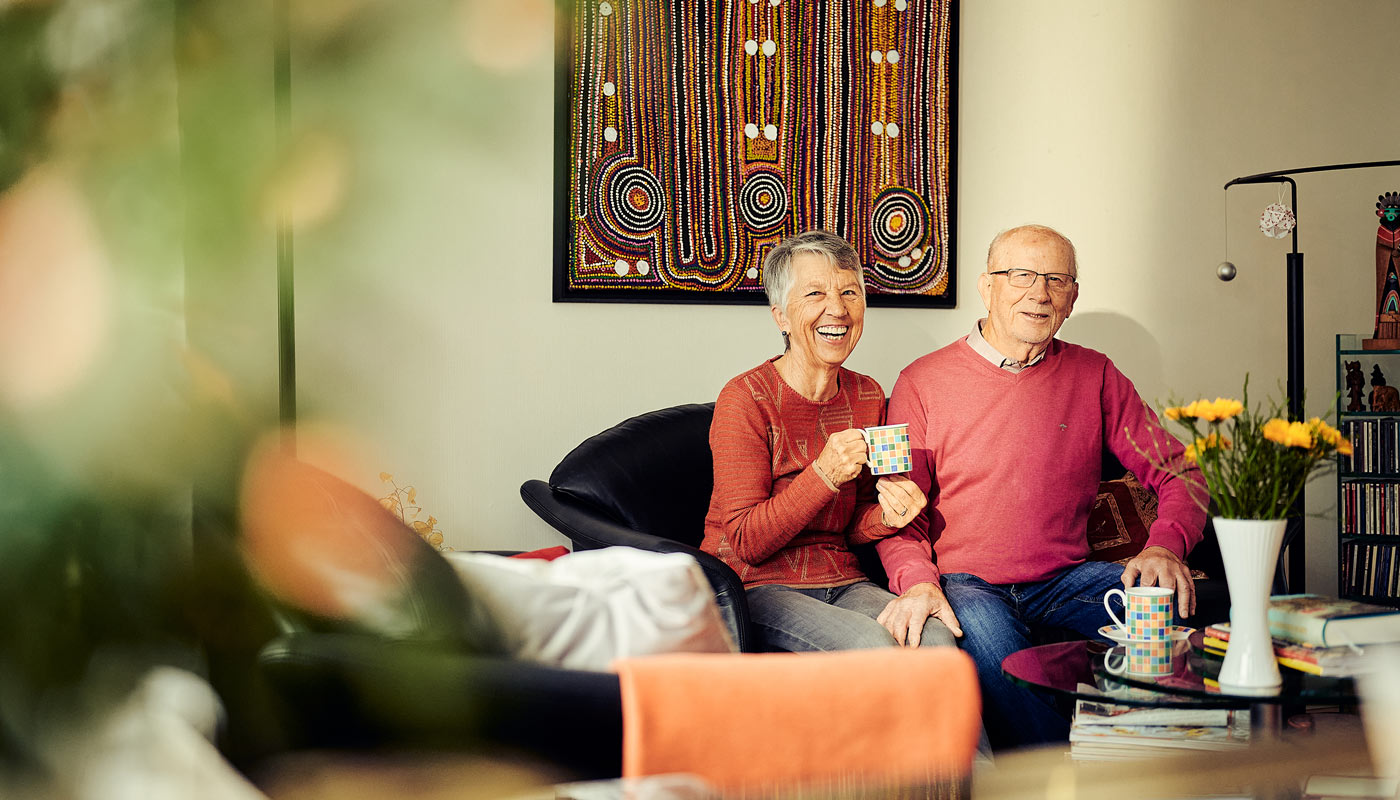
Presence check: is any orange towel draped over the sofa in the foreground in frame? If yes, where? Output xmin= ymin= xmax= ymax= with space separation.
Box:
xmin=616 ymin=647 xmax=981 ymax=790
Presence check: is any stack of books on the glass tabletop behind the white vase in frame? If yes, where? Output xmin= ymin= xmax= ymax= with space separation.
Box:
xmin=1203 ymin=594 xmax=1400 ymax=677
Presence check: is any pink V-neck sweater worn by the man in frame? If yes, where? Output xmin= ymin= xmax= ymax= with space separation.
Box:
xmin=878 ymin=339 xmax=1205 ymax=594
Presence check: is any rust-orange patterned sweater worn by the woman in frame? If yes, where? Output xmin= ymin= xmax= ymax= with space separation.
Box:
xmin=700 ymin=359 xmax=895 ymax=587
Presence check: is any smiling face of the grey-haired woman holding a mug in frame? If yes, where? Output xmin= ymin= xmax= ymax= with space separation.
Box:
xmin=773 ymin=252 xmax=865 ymax=370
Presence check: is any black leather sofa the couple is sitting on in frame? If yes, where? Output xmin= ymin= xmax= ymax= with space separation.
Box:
xmin=521 ymin=404 xmax=1229 ymax=651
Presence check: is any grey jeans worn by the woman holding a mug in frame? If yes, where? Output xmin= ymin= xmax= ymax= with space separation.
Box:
xmin=745 ymin=580 xmax=958 ymax=653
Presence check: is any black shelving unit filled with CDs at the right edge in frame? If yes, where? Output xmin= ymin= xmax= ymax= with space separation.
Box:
xmin=1337 ymin=333 xmax=1400 ymax=607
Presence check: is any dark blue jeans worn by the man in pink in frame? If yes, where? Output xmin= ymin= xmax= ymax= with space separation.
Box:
xmin=942 ymin=562 xmax=1123 ymax=750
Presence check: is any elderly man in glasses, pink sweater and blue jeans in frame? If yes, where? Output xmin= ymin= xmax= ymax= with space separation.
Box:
xmin=878 ymin=226 xmax=1205 ymax=748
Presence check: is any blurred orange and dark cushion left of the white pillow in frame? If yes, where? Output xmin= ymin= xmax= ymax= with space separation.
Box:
xmin=241 ymin=448 xmax=501 ymax=653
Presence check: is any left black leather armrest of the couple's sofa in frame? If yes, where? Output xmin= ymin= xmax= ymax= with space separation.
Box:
xmin=521 ymin=481 xmax=757 ymax=651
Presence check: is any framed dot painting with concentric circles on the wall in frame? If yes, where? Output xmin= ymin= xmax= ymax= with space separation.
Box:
xmin=554 ymin=0 xmax=956 ymax=307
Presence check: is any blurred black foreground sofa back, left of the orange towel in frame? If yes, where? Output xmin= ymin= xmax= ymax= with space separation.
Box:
xmin=258 ymin=630 xmax=622 ymax=780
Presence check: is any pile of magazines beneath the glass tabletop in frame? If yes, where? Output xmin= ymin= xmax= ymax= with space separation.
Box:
xmin=1070 ymin=688 xmax=1249 ymax=761
